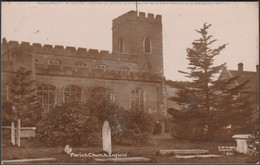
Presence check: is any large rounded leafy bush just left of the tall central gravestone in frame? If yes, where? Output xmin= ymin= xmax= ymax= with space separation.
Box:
xmin=36 ymin=103 xmax=94 ymax=145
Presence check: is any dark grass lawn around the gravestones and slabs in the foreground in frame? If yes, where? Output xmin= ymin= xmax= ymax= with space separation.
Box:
xmin=2 ymin=134 xmax=252 ymax=163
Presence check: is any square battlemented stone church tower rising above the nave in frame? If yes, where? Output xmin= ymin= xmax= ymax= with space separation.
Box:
xmin=112 ymin=11 xmax=163 ymax=75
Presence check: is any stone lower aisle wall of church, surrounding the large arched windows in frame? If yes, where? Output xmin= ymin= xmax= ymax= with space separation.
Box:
xmin=36 ymin=75 xmax=160 ymax=112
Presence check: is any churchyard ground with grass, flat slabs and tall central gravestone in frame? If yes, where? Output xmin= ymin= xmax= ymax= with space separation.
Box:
xmin=2 ymin=123 xmax=252 ymax=163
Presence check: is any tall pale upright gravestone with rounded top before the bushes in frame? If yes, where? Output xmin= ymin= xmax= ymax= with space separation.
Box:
xmin=102 ymin=121 xmax=112 ymax=154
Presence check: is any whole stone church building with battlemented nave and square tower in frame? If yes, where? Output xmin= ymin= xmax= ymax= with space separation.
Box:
xmin=1 ymin=11 xmax=166 ymax=114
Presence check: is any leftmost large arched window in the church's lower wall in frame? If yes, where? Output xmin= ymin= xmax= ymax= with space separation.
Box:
xmin=37 ymin=84 xmax=55 ymax=110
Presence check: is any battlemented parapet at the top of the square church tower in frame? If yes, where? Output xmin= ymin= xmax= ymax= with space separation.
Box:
xmin=113 ymin=10 xmax=162 ymax=26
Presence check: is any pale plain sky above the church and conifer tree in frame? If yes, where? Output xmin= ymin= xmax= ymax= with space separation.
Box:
xmin=1 ymin=2 xmax=259 ymax=81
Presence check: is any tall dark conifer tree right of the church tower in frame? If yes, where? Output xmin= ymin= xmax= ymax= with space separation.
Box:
xmin=168 ymin=23 xmax=254 ymax=140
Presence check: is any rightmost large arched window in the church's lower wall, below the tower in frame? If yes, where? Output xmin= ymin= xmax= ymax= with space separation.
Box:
xmin=130 ymin=88 xmax=146 ymax=111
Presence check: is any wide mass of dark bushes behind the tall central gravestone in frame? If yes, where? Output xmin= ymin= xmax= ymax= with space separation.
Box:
xmin=36 ymin=88 xmax=155 ymax=146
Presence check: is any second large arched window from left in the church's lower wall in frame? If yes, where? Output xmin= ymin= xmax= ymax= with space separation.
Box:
xmin=64 ymin=85 xmax=82 ymax=102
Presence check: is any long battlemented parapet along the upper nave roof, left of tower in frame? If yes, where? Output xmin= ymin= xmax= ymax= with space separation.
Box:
xmin=7 ymin=41 xmax=137 ymax=63
